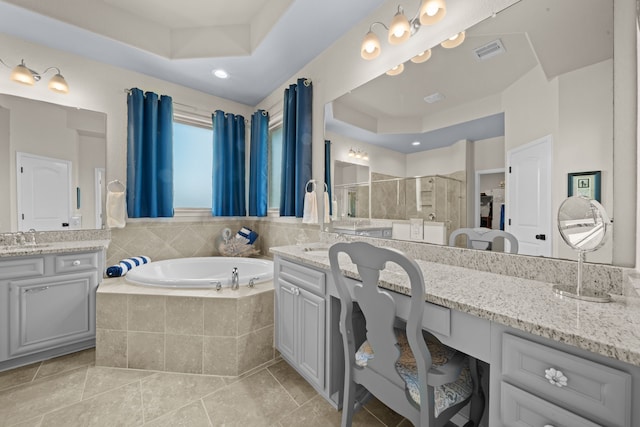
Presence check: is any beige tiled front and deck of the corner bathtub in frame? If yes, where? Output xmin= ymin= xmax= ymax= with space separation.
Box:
xmin=96 ymin=278 xmax=275 ymax=376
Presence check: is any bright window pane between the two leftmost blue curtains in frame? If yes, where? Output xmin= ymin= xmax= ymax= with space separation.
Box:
xmin=173 ymin=122 xmax=213 ymax=209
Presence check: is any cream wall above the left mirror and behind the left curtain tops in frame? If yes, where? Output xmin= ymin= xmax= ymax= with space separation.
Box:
xmin=0 ymin=34 xmax=255 ymax=196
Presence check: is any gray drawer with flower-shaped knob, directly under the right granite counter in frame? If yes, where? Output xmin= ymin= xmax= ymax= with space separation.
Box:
xmin=502 ymin=334 xmax=631 ymax=427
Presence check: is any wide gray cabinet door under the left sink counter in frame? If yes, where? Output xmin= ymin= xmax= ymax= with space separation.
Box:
xmin=9 ymin=272 xmax=98 ymax=356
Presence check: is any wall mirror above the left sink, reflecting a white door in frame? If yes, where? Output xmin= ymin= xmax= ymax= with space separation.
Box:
xmin=0 ymin=94 xmax=107 ymax=232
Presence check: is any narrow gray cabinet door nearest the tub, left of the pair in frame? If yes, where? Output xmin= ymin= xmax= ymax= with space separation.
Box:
xmin=276 ymin=280 xmax=297 ymax=363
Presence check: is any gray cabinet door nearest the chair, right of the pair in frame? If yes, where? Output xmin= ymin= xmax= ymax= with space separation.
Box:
xmin=297 ymin=289 xmax=325 ymax=388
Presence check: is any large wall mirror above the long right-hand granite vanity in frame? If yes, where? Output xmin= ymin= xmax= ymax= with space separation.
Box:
xmin=325 ymin=0 xmax=614 ymax=263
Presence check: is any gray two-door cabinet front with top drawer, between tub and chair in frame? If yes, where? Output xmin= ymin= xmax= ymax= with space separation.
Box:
xmin=275 ymin=259 xmax=325 ymax=390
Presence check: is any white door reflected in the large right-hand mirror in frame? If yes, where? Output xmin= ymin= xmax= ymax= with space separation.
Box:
xmin=505 ymin=135 xmax=552 ymax=256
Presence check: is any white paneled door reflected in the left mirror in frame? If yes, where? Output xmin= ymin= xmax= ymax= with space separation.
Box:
xmin=16 ymin=153 xmax=71 ymax=231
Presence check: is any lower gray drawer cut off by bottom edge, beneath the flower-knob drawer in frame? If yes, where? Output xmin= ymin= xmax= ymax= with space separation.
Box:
xmin=500 ymin=382 xmax=599 ymax=427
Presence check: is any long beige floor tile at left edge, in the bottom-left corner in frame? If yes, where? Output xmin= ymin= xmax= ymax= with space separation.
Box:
xmin=0 ymin=367 xmax=88 ymax=427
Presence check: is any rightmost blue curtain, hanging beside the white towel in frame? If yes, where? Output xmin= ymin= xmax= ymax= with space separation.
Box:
xmin=280 ymin=78 xmax=313 ymax=218
